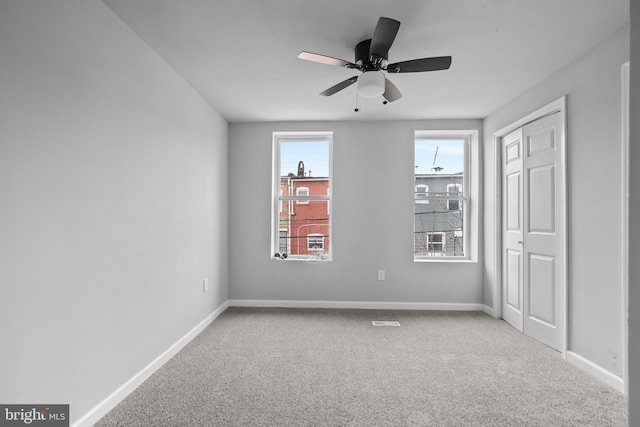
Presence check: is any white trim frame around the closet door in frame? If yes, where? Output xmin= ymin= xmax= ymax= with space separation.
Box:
xmin=493 ymin=95 xmax=570 ymax=358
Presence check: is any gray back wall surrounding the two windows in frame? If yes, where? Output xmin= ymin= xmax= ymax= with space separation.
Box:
xmin=229 ymin=120 xmax=482 ymax=304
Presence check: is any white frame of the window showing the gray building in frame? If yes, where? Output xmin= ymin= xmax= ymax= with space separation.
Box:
xmin=411 ymin=129 xmax=480 ymax=262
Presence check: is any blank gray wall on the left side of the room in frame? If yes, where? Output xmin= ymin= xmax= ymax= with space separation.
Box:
xmin=0 ymin=0 xmax=228 ymax=422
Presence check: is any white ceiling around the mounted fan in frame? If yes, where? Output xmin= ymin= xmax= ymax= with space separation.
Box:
xmin=104 ymin=0 xmax=629 ymax=122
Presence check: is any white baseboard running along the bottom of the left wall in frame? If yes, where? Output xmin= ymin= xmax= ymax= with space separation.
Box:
xmin=72 ymin=301 xmax=229 ymax=427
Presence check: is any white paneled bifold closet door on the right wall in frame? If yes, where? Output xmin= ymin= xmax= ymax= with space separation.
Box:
xmin=502 ymin=109 xmax=566 ymax=351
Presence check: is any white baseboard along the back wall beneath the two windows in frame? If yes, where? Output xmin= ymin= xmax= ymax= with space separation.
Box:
xmin=228 ymin=299 xmax=485 ymax=311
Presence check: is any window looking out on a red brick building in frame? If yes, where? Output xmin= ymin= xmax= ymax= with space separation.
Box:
xmin=271 ymin=132 xmax=333 ymax=260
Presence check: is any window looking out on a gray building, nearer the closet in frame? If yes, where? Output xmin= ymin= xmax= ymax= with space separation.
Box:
xmin=413 ymin=131 xmax=478 ymax=261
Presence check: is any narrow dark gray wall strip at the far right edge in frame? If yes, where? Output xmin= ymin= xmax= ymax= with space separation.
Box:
xmin=629 ymin=1 xmax=640 ymax=426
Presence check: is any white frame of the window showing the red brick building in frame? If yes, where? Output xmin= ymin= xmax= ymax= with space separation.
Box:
xmin=271 ymin=131 xmax=333 ymax=261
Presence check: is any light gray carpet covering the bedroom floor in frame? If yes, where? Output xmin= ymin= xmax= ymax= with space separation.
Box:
xmin=97 ymin=308 xmax=627 ymax=427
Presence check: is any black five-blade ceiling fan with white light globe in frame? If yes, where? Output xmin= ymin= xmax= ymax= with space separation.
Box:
xmin=298 ymin=17 xmax=451 ymax=104
